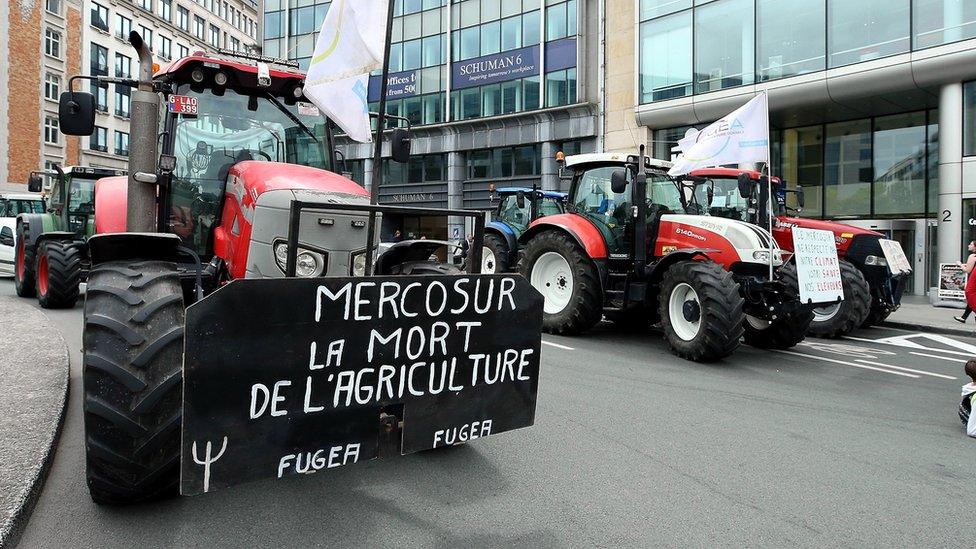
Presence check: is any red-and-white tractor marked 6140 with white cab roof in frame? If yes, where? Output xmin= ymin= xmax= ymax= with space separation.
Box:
xmin=519 ymin=148 xmax=813 ymax=361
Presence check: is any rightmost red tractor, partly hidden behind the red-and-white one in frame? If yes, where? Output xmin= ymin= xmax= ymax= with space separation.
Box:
xmin=689 ymin=168 xmax=910 ymax=337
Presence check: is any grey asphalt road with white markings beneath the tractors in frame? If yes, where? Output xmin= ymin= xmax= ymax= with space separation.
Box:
xmin=7 ymin=279 xmax=976 ymax=548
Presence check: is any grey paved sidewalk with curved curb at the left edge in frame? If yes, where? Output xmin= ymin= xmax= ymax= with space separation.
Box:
xmin=0 ymin=296 xmax=68 ymax=547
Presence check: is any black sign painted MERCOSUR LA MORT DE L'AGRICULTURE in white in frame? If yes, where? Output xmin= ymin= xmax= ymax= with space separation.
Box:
xmin=180 ymin=275 xmax=542 ymax=495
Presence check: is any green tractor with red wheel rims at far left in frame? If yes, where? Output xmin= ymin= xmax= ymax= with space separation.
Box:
xmin=14 ymin=166 xmax=125 ymax=309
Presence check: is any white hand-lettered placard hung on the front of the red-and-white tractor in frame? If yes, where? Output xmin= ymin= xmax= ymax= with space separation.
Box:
xmin=793 ymin=227 xmax=844 ymax=303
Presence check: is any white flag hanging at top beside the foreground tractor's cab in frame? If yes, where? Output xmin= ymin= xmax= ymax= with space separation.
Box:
xmin=305 ymin=0 xmax=392 ymax=143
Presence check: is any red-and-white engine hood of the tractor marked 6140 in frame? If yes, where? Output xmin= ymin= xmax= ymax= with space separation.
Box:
xmin=658 ymin=214 xmax=784 ymax=267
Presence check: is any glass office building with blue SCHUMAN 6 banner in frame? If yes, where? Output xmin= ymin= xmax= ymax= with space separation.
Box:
xmin=264 ymin=0 xmax=598 ymax=238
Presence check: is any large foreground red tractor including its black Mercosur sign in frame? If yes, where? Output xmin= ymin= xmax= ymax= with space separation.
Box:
xmin=60 ymin=34 xmax=541 ymax=504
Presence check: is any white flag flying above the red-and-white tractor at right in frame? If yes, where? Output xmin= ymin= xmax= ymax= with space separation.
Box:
xmin=668 ymin=92 xmax=769 ymax=175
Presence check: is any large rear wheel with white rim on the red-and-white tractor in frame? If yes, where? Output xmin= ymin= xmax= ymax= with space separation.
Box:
xmin=519 ymin=231 xmax=603 ymax=335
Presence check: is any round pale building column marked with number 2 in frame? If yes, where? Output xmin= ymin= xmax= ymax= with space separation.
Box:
xmin=931 ymin=82 xmax=963 ymax=300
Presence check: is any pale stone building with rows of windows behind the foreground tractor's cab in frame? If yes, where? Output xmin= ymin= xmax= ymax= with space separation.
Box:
xmin=83 ymin=0 xmax=260 ymax=169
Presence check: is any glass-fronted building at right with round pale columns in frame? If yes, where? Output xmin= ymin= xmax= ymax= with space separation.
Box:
xmin=628 ymin=0 xmax=976 ymax=294
